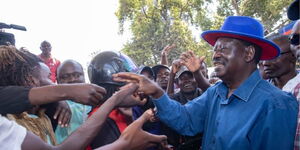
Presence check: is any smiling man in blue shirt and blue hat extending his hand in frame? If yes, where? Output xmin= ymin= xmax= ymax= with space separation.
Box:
xmin=114 ymin=16 xmax=298 ymax=150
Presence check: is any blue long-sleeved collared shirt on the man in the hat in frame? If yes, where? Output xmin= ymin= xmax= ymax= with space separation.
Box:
xmin=154 ymin=70 xmax=298 ymax=150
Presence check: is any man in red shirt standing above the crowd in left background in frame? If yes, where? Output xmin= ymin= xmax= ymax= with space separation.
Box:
xmin=39 ymin=41 xmax=60 ymax=83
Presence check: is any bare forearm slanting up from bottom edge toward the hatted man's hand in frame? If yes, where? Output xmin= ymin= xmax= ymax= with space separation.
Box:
xmin=58 ymin=99 xmax=115 ymax=150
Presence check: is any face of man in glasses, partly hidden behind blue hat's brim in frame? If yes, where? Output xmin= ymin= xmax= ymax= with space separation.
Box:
xmin=263 ymin=40 xmax=295 ymax=78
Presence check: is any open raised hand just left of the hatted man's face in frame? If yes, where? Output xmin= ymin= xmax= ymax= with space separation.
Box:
xmin=180 ymin=51 xmax=205 ymax=72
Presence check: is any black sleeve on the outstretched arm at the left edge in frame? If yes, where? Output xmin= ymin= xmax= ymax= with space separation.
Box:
xmin=0 ymin=86 xmax=32 ymax=115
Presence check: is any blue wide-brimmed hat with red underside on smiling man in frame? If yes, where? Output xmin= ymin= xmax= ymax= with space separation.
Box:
xmin=201 ymin=16 xmax=280 ymax=60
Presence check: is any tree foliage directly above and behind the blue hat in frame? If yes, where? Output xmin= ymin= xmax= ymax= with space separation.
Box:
xmin=217 ymin=0 xmax=293 ymax=34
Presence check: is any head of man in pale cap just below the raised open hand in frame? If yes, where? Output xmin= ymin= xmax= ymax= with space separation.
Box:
xmin=175 ymin=66 xmax=197 ymax=94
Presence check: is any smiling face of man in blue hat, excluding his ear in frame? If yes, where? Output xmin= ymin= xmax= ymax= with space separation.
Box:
xmin=213 ymin=38 xmax=244 ymax=81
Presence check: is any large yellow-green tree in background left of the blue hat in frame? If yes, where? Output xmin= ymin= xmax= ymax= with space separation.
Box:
xmin=116 ymin=0 xmax=211 ymax=65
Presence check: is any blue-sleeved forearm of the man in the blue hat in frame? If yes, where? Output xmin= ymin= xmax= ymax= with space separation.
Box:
xmin=153 ymin=94 xmax=205 ymax=136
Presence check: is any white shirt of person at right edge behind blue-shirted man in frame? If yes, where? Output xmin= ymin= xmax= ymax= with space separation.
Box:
xmin=282 ymin=73 xmax=300 ymax=150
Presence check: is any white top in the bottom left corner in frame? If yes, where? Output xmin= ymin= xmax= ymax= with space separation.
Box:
xmin=0 ymin=115 xmax=27 ymax=150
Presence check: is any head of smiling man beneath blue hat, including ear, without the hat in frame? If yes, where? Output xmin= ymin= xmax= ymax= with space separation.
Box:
xmin=213 ymin=37 xmax=261 ymax=81
